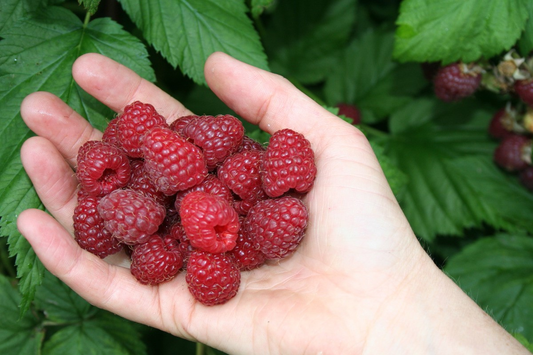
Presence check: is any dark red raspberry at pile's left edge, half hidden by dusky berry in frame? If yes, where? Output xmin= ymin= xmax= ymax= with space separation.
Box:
xmin=73 ymin=196 xmax=122 ymax=259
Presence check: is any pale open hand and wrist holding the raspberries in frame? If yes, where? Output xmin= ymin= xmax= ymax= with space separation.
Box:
xmin=17 ymin=53 xmax=529 ymax=354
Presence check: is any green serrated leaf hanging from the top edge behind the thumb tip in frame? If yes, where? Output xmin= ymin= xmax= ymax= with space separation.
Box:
xmin=120 ymin=0 xmax=268 ymax=84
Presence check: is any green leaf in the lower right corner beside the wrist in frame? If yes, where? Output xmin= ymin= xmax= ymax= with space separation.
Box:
xmin=444 ymin=234 xmax=533 ymax=338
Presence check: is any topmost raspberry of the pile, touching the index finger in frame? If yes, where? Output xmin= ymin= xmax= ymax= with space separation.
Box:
xmin=117 ymin=101 xmax=168 ymax=158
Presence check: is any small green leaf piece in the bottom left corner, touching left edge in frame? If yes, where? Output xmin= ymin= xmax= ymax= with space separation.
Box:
xmin=0 ymin=275 xmax=44 ymax=355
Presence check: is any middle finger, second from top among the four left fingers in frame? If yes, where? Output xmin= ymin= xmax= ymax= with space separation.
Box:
xmin=20 ymin=92 xmax=102 ymax=166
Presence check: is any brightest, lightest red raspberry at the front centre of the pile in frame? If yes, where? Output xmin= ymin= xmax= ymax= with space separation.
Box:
xmin=180 ymin=191 xmax=240 ymax=253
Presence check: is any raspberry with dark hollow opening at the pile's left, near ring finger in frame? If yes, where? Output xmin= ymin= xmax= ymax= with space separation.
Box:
xmin=76 ymin=141 xmax=131 ymax=196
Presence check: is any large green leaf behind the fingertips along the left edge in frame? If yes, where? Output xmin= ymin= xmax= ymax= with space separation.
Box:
xmin=0 ymin=7 xmax=155 ymax=313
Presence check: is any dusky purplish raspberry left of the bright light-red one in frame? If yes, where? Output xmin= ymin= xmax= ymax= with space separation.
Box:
xmin=98 ymin=190 xmax=165 ymax=245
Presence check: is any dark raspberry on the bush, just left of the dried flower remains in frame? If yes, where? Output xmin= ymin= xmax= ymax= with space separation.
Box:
xmin=433 ymin=63 xmax=481 ymax=102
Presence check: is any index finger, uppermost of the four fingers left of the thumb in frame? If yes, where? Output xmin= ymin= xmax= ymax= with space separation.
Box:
xmin=72 ymin=53 xmax=191 ymax=122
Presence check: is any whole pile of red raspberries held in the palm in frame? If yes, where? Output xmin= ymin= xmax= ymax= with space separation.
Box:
xmin=73 ymin=101 xmax=316 ymax=306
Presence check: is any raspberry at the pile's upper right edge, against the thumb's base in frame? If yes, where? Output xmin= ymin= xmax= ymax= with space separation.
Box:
xmin=261 ymin=129 xmax=316 ymax=197
